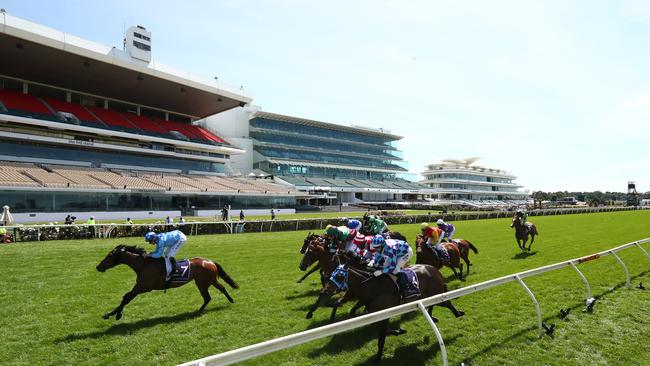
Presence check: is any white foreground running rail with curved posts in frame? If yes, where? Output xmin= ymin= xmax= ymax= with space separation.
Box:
xmin=181 ymin=238 xmax=650 ymax=366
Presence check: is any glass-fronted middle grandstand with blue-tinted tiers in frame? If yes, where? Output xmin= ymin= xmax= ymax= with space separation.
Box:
xmin=206 ymin=107 xmax=430 ymax=204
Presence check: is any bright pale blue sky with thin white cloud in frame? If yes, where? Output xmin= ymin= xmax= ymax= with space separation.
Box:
xmin=0 ymin=0 xmax=650 ymax=192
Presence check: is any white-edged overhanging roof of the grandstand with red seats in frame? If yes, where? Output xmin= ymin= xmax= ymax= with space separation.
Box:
xmin=0 ymin=12 xmax=252 ymax=118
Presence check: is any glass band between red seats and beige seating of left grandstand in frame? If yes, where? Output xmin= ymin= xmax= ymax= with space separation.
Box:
xmin=0 ymin=141 xmax=224 ymax=173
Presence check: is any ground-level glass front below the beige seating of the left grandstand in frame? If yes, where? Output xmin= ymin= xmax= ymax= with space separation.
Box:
xmin=0 ymin=190 xmax=296 ymax=213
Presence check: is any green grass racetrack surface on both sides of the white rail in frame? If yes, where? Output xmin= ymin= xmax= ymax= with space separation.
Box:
xmin=0 ymin=211 xmax=650 ymax=365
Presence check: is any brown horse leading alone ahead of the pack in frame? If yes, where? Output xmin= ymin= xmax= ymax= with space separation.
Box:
xmin=97 ymin=245 xmax=239 ymax=320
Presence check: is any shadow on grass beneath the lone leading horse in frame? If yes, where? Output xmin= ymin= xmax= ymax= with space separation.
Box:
xmin=54 ymin=304 xmax=229 ymax=344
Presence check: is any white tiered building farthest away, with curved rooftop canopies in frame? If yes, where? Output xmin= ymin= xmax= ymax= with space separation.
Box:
xmin=419 ymin=158 xmax=528 ymax=204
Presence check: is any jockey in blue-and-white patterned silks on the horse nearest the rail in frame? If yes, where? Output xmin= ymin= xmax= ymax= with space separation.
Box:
xmin=368 ymin=235 xmax=415 ymax=299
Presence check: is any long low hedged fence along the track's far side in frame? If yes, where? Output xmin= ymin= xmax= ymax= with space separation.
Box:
xmin=6 ymin=207 xmax=648 ymax=242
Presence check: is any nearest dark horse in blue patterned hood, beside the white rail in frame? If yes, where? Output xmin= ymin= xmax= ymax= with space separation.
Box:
xmin=319 ymin=258 xmax=465 ymax=362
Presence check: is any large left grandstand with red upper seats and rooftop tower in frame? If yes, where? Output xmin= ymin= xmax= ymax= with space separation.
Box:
xmin=0 ymin=13 xmax=301 ymax=220
